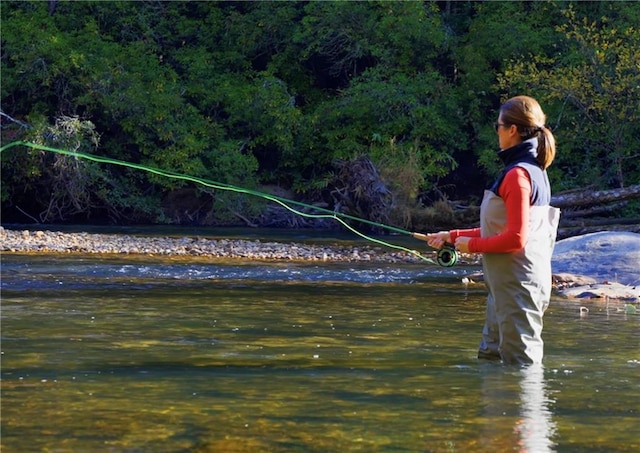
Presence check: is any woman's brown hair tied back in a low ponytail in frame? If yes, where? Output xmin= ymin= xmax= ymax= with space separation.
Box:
xmin=500 ymin=96 xmax=556 ymax=169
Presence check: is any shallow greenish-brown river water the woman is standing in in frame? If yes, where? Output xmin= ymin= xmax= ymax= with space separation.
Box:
xmin=1 ymin=247 xmax=640 ymax=453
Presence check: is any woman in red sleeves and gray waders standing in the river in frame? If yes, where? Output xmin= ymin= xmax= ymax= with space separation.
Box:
xmin=417 ymin=96 xmax=560 ymax=364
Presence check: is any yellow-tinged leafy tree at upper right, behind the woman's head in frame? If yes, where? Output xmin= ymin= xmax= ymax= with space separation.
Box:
xmin=499 ymin=3 xmax=640 ymax=188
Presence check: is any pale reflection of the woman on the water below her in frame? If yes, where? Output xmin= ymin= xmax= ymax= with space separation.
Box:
xmin=481 ymin=363 xmax=556 ymax=453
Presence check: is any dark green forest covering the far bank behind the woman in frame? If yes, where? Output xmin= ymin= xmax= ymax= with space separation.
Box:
xmin=0 ymin=0 xmax=640 ymax=230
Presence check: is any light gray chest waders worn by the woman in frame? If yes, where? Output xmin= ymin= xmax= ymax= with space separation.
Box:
xmin=478 ymin=190 xmax=560 ymax=364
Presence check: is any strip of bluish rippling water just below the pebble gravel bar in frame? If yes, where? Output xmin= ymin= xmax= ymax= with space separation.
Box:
xmin=2 ymin=254 xmax=475 ymax=291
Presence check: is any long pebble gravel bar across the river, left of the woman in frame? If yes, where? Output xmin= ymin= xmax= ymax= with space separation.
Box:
xmin=0 ymin=227 xmax=464 ymax=263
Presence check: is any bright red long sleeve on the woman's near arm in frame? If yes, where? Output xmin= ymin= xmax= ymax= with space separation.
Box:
xmin=469 ymin=167 xmax=531 ymax=253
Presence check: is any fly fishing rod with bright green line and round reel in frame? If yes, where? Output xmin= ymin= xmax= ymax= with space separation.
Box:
xmin=0 ymin=141 xmax=458 ymax=267
